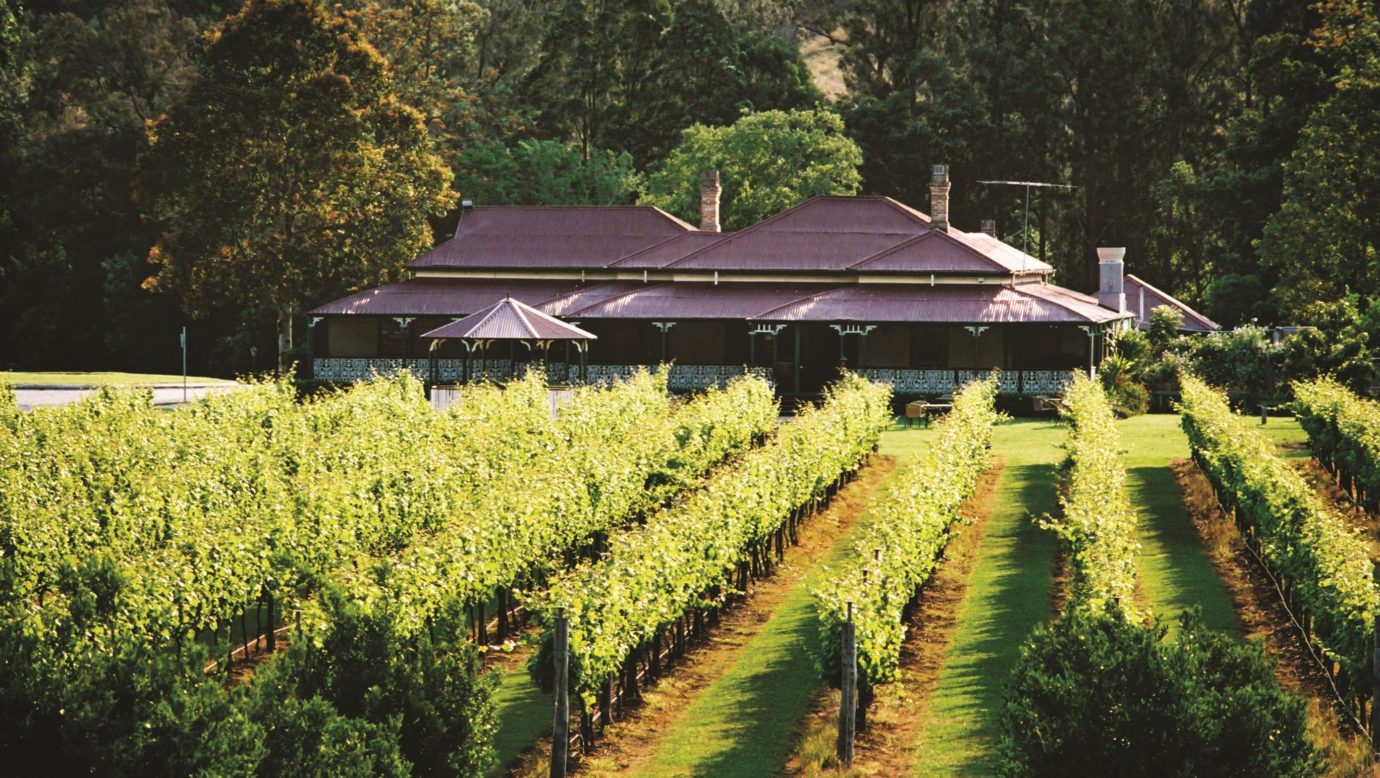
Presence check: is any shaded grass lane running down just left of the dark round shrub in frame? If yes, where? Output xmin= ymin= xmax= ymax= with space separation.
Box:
xmin=912 ymin=421 xmax=1067 ymax=775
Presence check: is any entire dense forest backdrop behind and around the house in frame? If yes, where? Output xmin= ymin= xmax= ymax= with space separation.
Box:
xmin=0 ymin=0 xmax=1380 ymax=374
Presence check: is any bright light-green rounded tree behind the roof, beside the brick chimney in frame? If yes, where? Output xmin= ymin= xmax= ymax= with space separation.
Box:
xmin=640 ymin=109 xmax=863 ymax=229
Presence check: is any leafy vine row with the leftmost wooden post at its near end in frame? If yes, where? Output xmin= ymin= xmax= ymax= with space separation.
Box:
xmin=534 ymin=375 xmax=890 ymax=702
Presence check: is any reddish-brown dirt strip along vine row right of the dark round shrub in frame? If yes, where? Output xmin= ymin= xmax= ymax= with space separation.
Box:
xmin=1173 ymin=459 xmax=1372 ymax=775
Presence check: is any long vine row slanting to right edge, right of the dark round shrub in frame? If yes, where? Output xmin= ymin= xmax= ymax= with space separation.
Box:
xmin=1180 ymin=375 xmax=1380 ymax=701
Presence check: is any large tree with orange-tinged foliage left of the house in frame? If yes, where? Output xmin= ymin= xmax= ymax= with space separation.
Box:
xmin=144 ymin=0 xmax=454 ymax=370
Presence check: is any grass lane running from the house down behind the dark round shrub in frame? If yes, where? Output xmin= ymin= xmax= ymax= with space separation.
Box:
xmin=1118 ymin=414 xmax=1247 ymax=636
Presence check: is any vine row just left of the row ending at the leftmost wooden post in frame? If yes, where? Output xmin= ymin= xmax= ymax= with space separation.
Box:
xmin=318 ymin=374 xmax=778 ymax=637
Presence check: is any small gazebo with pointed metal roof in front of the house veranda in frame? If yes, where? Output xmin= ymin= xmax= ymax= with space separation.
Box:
xmin=422 ymin=297 xmax=596 ymax=383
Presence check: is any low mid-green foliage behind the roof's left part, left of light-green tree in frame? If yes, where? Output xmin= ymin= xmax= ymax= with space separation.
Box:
xmin=455 ymin=141 xmax=642 ymax=206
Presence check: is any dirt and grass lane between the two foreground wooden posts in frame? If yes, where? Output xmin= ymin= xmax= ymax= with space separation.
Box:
xmin=519 ymin=457 xmax=896 ymax=777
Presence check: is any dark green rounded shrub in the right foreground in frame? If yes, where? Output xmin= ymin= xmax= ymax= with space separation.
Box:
xmin=999 ymin=610 xmax=1322 ymax=778
